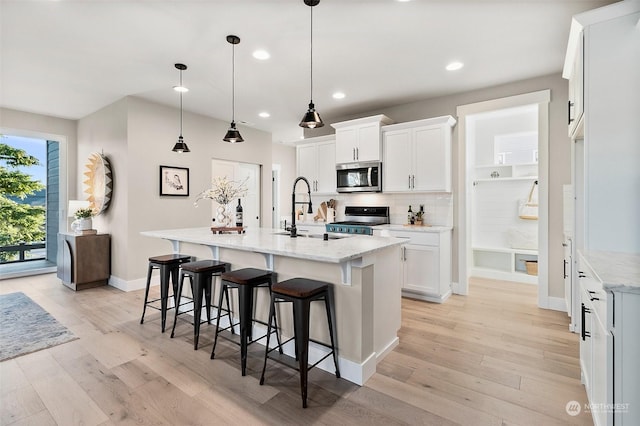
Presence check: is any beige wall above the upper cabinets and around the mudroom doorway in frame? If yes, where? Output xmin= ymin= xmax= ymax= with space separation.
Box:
xmin=305 ymin=72 xmax=571 ymax=297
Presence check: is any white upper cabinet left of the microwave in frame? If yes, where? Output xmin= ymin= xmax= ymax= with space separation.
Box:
xmin=296 ymin=136 xmax=336 ymax=194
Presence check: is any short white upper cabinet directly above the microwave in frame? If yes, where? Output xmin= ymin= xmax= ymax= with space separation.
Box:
xmin=331 ymin=115 xmax=393 ymax=164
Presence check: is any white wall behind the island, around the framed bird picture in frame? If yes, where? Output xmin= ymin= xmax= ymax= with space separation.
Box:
xmin=78 ymin=97 xmax=271 ymax=288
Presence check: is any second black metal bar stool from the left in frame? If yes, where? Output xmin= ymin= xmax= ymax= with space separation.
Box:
xmin=171 ymin=260 xmax=233 ymax=350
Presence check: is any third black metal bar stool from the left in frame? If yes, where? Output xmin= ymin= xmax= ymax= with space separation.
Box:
xmin=211 ymin=268 xmax=280 ymax=376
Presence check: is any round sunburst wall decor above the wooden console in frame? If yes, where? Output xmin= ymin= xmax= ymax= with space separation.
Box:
xmin=83 ymin=152 xmax=113 ymax=216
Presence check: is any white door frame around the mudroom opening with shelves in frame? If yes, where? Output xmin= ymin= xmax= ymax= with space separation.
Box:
xmin=455 ymin=90 xmax=551 ymax=307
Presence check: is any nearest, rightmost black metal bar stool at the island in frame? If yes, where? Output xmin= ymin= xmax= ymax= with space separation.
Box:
xmin=260 ymin=278 xmax=340 ymax=408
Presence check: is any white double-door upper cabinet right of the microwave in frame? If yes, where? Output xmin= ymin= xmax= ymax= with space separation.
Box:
xmin=382 ymin=115 xmax=456 ymax=192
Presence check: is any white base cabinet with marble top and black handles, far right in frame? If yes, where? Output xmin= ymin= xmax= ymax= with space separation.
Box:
xmin=578 ymin=251 xmax=640 ymax=426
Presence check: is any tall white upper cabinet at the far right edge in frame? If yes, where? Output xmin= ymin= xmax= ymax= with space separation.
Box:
xmin=563 ymin=1 xmax=640 ymax=253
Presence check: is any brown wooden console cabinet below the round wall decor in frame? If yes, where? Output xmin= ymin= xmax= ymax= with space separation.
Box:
xmin=58 ymin=234 xmax=111 ymax=290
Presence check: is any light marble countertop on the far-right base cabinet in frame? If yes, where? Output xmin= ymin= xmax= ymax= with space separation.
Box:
xmin=580 ymin=250 xmax=640 ymax=291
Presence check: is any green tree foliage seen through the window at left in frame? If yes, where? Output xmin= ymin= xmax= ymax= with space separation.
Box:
xmin=0 ymin=143 xmax=46 ymax=262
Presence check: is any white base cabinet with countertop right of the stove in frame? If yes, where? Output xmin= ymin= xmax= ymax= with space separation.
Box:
xmin=374 ymin=229 xmax=451 ymax=303
